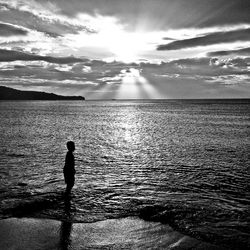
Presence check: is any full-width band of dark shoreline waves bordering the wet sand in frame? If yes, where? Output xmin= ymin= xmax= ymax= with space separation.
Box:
xmin=0 ymin=191 xmax=250 ymax=249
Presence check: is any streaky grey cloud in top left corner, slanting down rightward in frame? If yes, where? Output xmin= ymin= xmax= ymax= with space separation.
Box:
xmin=0 ymin=0 xmax=94 ymax=38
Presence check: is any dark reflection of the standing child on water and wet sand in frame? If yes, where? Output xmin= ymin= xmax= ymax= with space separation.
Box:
xmin=60 ymin=196 xmax=72 ymax=250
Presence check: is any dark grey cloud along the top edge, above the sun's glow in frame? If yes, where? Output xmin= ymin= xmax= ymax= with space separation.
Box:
xmin=44 ymin=0 xmax=250 ymax=30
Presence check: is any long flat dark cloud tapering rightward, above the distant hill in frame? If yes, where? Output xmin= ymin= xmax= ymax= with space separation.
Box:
xmin=0 ymin=49 xmax=86 ymax=64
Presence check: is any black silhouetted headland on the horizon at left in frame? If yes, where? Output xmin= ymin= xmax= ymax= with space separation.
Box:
xmin=0 ymin=86 xmax=85 ymax=101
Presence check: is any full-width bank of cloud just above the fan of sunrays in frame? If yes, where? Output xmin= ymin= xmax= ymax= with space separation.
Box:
xmin=0 ymin=49 xmax=250 ymax=84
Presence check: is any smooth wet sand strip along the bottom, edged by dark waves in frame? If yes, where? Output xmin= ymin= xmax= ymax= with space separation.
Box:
xmin=0 ymin=217 xmax=227 ymax=250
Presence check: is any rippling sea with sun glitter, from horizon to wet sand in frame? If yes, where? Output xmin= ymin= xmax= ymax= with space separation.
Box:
xmin=0 ymin=99 xmax=250 ymax=249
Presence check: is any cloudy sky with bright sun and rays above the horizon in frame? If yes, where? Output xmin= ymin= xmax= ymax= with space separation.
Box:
xmin=0 ymin=0 xmax=250 ymax=100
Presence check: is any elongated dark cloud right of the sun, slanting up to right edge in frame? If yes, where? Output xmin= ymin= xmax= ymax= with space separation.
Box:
xmin=157 ymin=28 xmax=250 ymax=50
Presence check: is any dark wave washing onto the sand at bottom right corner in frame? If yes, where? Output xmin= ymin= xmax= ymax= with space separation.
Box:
xmin=139 ymin=205 xmax=250 ymax=249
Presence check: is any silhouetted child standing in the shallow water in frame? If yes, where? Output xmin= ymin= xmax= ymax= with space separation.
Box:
xmin=63 ymin=141 xmax=76 ymax=194
